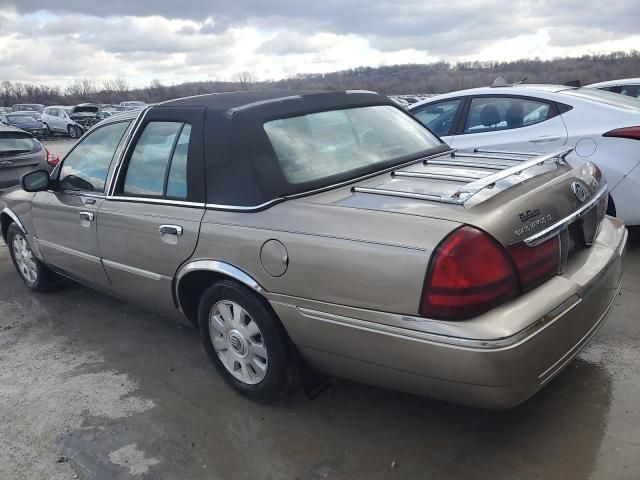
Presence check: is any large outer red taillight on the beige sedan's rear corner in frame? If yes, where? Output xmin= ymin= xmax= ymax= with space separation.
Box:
xmin=420 ymin=226 xmax=518 ymax=320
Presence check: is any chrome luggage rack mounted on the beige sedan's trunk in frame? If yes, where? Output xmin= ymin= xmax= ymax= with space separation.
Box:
xmin=353 ymin=147 xmax=573 ymax=205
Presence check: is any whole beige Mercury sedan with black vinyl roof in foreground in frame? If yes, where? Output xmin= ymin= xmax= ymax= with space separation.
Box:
xmin=0 ymin=91 xmax=627 ymax=408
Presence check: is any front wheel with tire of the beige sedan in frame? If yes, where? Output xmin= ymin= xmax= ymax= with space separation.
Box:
xmin=7 ymin=223 xmax=58 ymax=292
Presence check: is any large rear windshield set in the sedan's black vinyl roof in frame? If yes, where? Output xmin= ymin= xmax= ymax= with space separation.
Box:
xmin=264 ymin=105 xmax=442 ymax=184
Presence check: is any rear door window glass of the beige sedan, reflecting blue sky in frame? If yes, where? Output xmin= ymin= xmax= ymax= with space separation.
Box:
xmin=123 ymin=122 xmax=191 ymax=199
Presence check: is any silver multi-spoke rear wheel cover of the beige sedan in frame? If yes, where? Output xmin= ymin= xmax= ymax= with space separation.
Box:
xmin=209 ymin=300 xmax=269 ymax=385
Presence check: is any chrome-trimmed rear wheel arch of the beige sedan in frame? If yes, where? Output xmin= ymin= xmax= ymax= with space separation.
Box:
xmin=174 ymin=260 xmax=271 ymax=327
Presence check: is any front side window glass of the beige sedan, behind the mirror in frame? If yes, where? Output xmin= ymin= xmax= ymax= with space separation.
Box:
xmin=58 ymin=121 xmax=129 ymax=193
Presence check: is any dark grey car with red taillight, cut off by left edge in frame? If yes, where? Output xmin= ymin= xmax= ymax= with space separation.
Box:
xmin=0 ymin=125 xmax=59 ymax=190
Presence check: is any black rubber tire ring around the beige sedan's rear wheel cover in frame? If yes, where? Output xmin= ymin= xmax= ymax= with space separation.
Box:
xmin=198 ymin=280 xmax=298 ymax=403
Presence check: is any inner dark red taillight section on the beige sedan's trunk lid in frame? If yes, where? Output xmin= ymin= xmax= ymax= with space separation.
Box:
xmin=509 ymin=235 xmax=560 ymax=292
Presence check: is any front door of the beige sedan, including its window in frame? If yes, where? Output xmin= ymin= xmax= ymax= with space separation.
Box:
xmin=32 ymin=120 xmax=130 ymax=286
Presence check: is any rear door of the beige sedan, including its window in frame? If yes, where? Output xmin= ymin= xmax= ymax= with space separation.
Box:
xmin=98 ymin=107 xmax=205 ymax=315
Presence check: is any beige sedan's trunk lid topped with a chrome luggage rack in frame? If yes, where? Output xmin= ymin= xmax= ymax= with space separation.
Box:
xmin=307 ymin=148 xmax=607 ymax=246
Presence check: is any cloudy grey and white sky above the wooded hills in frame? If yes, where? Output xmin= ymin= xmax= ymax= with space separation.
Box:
xmin=0 ymin=0 xmax=640 ymax=85
